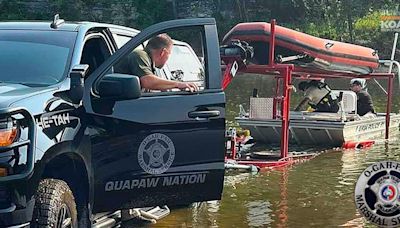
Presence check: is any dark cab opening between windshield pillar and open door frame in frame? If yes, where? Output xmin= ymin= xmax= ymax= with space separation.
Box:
xmin=81 ymin=34 xmax=111 ymax=77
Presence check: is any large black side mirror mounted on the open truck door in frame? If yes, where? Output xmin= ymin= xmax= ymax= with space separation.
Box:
xmin=97 ymin=74 xmax=141 ymax=101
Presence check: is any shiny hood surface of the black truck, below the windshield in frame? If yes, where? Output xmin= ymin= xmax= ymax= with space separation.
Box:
xmin=0 ymin=83 xmax=54 ymax=109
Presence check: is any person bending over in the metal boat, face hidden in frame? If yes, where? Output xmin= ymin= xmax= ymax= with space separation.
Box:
xmin=295 ymin=80 xmax=339 ymax=113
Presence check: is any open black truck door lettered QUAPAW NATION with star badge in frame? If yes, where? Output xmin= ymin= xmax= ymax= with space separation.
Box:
xmin=83 ymin=18 xmax=225 ymax=212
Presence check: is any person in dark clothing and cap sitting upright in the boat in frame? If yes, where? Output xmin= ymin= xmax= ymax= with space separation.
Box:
xmin=350 ymin=78 xmax=376 ymax=117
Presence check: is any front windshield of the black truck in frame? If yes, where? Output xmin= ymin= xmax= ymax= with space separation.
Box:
xmin=0 ymin=30 xmax=77 ymax=86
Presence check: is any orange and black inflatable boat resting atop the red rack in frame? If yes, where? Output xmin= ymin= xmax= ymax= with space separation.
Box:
xmin=222 ymin=22 xmax=379 ymax=74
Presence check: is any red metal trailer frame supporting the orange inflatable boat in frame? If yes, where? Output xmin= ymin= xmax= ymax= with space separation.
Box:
xmin=220 ymin=19 xmax=400 ymax=171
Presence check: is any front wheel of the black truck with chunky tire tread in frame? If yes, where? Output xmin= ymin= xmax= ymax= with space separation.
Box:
xmin=32 ymin=179 xmax=78 ymax=228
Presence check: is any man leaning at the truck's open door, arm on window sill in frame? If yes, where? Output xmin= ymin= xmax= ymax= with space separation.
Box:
xmin=117 ymin=33 xmax=199 ymax=92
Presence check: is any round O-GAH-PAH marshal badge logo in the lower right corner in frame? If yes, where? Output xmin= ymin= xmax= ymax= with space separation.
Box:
xmin=355 ymin=161 xmax=400 ymax=227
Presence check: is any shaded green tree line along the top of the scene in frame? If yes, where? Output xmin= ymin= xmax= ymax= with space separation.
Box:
xmin=0 ymin=0 xmax=400 ymax=58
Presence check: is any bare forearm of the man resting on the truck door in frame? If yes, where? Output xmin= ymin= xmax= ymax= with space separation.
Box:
xmin=140 ymin=74 xmax=199 ymax=92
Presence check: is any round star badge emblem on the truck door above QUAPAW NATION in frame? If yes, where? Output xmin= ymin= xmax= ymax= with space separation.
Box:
xmin=138 ymin=133 xmax=175 ymax=174
